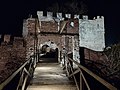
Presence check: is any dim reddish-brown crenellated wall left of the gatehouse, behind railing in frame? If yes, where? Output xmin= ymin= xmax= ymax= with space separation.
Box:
xmin=0 ymin=35 xmax=26 ymax=83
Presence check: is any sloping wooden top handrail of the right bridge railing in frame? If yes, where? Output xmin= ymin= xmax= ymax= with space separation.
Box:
xmin=68 ymin=57 xmax=117 ymax=90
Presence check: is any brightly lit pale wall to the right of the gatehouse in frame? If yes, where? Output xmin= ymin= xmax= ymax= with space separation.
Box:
xmin=79 ymin=16 xmax=105 ymax=51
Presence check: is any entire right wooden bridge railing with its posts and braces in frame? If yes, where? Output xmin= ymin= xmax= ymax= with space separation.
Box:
xmin=65 ymin=55 xmax=117 ymax=90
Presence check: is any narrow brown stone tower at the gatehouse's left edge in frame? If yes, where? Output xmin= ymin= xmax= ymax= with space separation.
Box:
xmin=23 ymin=18 xmax=38 ymax=58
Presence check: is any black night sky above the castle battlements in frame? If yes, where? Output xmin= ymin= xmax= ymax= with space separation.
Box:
xmin=0 ymin=0 xmax=120 ymax=45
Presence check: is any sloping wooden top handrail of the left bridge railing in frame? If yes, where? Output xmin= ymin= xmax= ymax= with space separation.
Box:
xmin=0 ymin=57 xmax=32 ymax=90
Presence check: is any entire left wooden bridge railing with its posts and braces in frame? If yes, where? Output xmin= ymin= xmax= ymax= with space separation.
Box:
xmin=0 ymin=56 xmax=36 ymax=90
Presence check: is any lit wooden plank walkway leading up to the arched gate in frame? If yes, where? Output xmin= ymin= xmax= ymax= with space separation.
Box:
xmin=27 ymin=63 xmax=77 ymax=90
